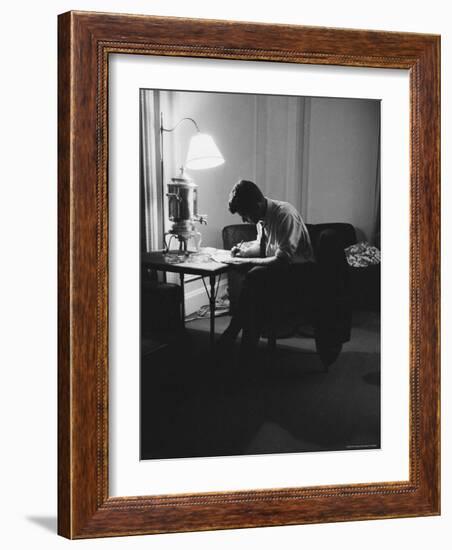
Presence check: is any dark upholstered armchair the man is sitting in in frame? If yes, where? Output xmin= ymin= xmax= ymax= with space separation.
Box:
xmin=223 ymin=223 xmax=356 ymax=368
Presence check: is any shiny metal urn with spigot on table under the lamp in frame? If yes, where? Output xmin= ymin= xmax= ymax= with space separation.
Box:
xmin=165 ymin=168 xmax=207 ymax=255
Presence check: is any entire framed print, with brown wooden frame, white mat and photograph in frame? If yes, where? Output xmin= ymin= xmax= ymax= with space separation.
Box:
xmin=58 ymin=12 xmax=440 ymax=538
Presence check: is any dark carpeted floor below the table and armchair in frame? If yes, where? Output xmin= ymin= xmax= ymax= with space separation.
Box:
xmin=141 ymin=312 xmax=380 ymax=459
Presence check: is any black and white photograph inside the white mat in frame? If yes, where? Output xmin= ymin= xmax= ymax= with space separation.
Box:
xmin=139 ymin=89 xmax=381 ymax=460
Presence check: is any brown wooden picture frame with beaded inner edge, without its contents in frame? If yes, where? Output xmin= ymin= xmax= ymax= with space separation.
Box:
xmin=58 ymin=12 xmax=440 ymax=538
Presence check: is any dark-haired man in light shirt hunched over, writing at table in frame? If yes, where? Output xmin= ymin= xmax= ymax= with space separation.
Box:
xmin=219 ymin=180 xmax=314 ymax=365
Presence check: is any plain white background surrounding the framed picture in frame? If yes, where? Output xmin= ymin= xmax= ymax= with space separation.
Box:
xmin=0 ymin=0 xmax=452 ymax=550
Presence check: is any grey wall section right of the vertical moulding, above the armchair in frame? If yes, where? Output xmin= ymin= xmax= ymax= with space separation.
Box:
xmin=304 ymin=98 xmax=380 ymax=240
